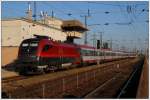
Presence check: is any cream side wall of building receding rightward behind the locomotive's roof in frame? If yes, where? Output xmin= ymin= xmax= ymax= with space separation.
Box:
xmin=21 ymin=21 xmax=67 ymax=41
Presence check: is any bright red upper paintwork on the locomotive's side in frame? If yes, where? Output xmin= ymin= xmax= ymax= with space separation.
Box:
xmin=37 ymin=39 xmax=80 ymax=61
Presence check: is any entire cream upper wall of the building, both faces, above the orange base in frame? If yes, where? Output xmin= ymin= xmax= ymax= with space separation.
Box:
xmin=2 ymin=19 xmax=67 ymax=46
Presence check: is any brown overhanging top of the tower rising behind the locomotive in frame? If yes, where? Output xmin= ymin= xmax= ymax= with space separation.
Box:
xmin=62 ymin=20 xmax=88 ymax=32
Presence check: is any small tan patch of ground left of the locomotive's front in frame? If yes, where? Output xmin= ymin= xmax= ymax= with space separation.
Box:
xmin=1 ymin=69 xmax=19 ymax=79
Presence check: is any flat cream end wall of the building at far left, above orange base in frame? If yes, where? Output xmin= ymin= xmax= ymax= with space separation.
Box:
xmin=2 ymin=20 xmax=21 ymax=46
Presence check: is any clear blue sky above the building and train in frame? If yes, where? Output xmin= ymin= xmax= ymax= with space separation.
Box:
xmin=1 ymin=1 xmax=149 ymax=50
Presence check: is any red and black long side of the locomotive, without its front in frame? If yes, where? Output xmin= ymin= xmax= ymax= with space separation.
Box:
xmin=39 ymin=43 xmax=80 ymax=67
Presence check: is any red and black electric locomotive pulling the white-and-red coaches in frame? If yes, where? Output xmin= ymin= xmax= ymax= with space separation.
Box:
xmin=18 ymin=35 xmax=81 ymax=73
